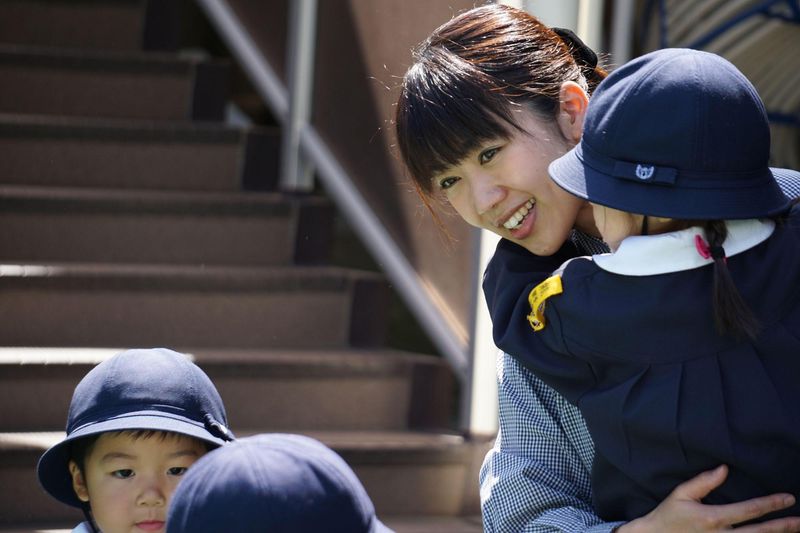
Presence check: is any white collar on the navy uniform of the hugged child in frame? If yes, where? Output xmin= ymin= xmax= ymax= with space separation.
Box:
xmin=592 ymin=219 xmax=775 ymax=276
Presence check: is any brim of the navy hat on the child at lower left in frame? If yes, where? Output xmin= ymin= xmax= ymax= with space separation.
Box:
xmin=36 ymin=411 xmax=225 ymax=508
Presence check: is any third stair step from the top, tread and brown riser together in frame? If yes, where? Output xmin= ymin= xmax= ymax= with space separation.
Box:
xmin=0 ymin=114 xmax=280 ymax=192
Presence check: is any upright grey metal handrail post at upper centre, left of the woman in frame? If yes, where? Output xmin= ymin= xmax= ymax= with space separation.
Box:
xmin=280 ymin=0 xmax=317 ymax=191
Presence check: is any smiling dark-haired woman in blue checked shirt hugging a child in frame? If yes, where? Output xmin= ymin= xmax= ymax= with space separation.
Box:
xmin=395 ymin=4 xmax=798 ymax=533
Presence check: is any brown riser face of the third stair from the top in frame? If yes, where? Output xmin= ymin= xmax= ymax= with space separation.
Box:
xmin=0 ymin=131 xmax=278 ymax=191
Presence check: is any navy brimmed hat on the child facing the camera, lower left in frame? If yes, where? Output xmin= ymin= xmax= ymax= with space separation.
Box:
xmin=36 ymin=348 xmax=233 ymax=507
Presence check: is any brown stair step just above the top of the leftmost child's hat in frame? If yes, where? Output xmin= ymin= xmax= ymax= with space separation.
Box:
xmin=0 ymin=264 xmax=389 ymax=348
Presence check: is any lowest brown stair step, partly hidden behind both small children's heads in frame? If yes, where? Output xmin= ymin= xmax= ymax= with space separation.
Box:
xmin=0 ymin=431 xmax=489 ymax=531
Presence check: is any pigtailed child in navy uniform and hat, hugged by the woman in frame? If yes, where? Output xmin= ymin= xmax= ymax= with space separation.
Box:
xmin=484 ymin=49 xmax=800 ymax=520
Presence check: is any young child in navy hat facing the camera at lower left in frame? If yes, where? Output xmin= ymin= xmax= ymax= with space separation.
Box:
xmin=37 ymin=348 xmax=233 ymax=533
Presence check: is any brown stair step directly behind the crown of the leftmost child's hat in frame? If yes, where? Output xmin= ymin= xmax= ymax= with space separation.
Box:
xmin=0 ymin=348 xmax=455 ymax=432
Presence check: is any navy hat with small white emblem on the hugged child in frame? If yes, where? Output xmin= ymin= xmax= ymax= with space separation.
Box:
xmin=549 ymin=48 xmax=800 ymax=220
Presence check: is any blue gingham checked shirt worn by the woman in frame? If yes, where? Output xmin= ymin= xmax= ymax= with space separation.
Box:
xmin=480 ymin=176 xmax=800 ymax=533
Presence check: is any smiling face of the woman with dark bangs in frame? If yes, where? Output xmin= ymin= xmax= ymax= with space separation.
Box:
xmin=433 ymin=106 xmax=591 ymax=255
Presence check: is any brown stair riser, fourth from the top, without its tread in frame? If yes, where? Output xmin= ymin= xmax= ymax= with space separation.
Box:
xmin=0 ymin=210 xmax=296 ymax=265
